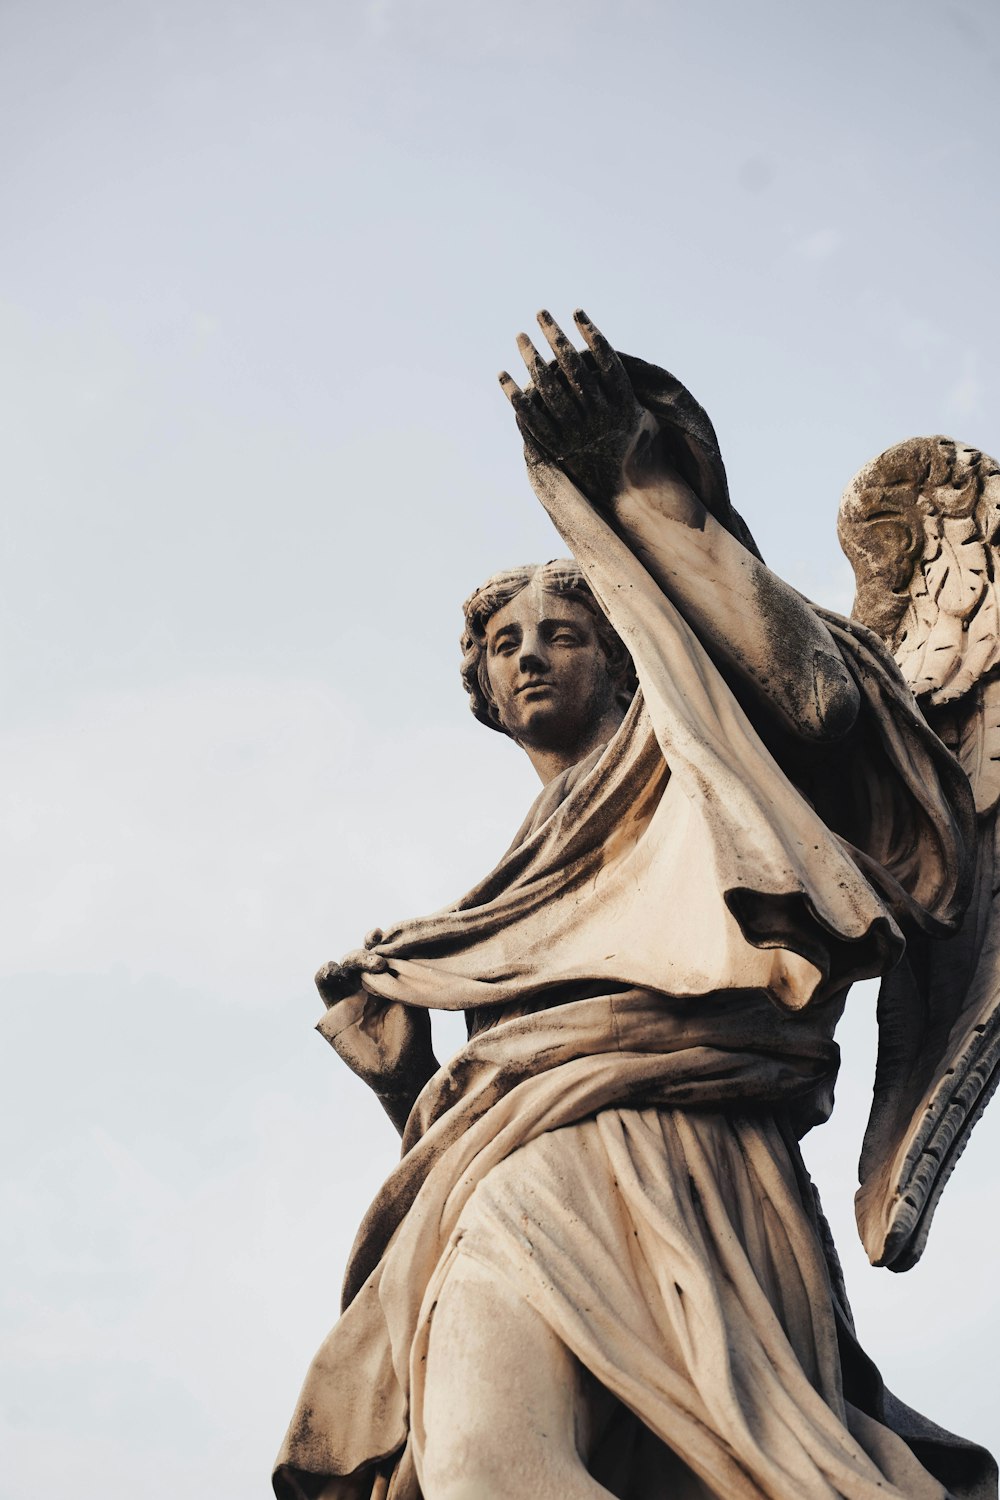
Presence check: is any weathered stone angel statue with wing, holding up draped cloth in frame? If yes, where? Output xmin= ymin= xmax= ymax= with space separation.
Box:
xmin=274 ymin=312 xmax=1000 ymax=1500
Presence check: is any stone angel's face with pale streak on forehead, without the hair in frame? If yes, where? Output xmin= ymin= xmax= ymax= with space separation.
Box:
xmin=486 ymin=582 xmax=615 ymax=750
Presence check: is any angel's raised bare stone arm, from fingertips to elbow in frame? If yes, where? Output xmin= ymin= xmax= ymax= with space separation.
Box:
xmin=501 ymin=312 xmax=859 ymax=743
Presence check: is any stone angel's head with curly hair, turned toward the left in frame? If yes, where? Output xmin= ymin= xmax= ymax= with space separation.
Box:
xmin=462 ymin=561 xmax=637 ymax=755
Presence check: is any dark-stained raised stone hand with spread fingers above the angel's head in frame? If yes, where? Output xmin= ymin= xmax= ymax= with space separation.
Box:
xmin=499 ymin=309 xmax=655 ymax=506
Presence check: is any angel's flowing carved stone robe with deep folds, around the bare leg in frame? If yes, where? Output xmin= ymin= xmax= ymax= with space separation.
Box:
xmin=274 ymin=381 xmax=997 ymax=1500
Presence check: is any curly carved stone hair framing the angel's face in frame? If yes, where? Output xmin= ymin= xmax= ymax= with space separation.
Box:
xmin=462 ymin=558 xmax=639 ymax=735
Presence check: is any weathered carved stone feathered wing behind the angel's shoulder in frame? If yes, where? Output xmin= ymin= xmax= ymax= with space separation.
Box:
xmin=838 ymin=437 xmax=1000 ymax=1271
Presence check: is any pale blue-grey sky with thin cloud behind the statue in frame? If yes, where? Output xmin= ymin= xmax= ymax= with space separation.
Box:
xmin=0 ymin=0 xmax=1000 ymax=1500
